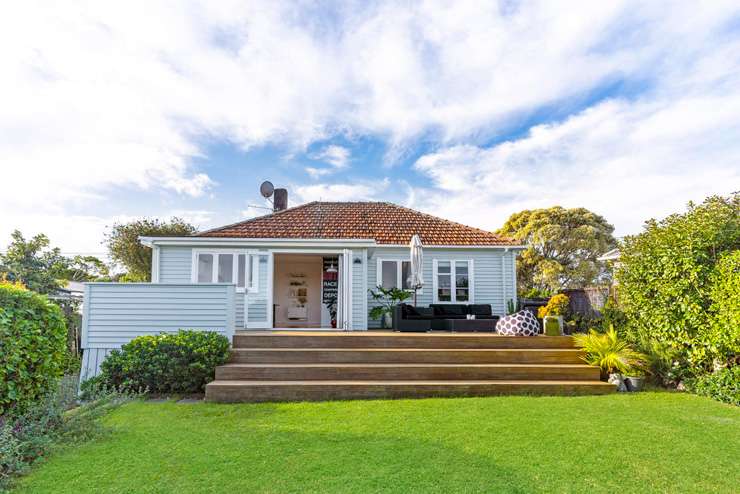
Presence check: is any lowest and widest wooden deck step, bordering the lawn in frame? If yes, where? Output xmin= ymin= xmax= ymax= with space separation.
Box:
xmin=206 ymin=380 xmax=614 ymax=403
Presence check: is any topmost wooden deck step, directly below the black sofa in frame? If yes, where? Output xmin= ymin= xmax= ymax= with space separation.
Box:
xmin=234 ymin=331 xmax=573 ymax=349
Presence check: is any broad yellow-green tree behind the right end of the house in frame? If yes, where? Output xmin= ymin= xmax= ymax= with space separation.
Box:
xmin=497 ymin=206 xmax=617 ymax=293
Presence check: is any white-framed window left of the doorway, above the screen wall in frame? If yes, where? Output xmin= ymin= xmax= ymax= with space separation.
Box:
xmin=192 ymin=249 xmax=259 ymax=292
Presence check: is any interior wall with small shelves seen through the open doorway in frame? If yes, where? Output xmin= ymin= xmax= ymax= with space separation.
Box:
xmin=274 ymin=254 xmax=323 ymax=328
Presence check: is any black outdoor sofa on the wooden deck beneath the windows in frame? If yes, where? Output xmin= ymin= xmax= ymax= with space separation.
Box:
xmin=393 ymin=304 xmax=499 ymax=333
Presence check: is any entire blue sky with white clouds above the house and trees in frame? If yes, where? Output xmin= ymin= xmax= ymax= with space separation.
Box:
xmin=0 ymin=0 xmax=740 ymax=252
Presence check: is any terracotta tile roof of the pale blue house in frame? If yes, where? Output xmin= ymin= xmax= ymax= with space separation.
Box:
xmin=195 ymin=202 xmax=518 ymax=245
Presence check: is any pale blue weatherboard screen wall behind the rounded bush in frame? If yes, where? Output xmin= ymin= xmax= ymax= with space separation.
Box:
xmin=81 ymin=283 xmax=235 ymax=379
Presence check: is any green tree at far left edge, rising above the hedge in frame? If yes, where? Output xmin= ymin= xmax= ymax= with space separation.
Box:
xmin=0 ymin=230 xmax=69 ymax=293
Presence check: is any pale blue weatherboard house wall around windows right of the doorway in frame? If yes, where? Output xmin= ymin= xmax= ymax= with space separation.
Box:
xmin=367 ymin=248 xmax=516 ymax=328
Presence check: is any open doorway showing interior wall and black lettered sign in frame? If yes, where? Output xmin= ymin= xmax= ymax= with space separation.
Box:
xmin=273 ymin=254 xmax=339 ymax=329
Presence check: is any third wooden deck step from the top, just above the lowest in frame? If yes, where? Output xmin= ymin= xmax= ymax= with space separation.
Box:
xmin=216 ymin=363 xmax=599 ymax=381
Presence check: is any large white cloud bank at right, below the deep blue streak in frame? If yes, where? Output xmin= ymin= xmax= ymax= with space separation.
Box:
xmin=414 ymin=92 xmax=740 ymax=235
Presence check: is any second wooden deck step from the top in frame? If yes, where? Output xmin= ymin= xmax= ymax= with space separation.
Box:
xmin=231 ymin=348 xmax=583 ymax=364
